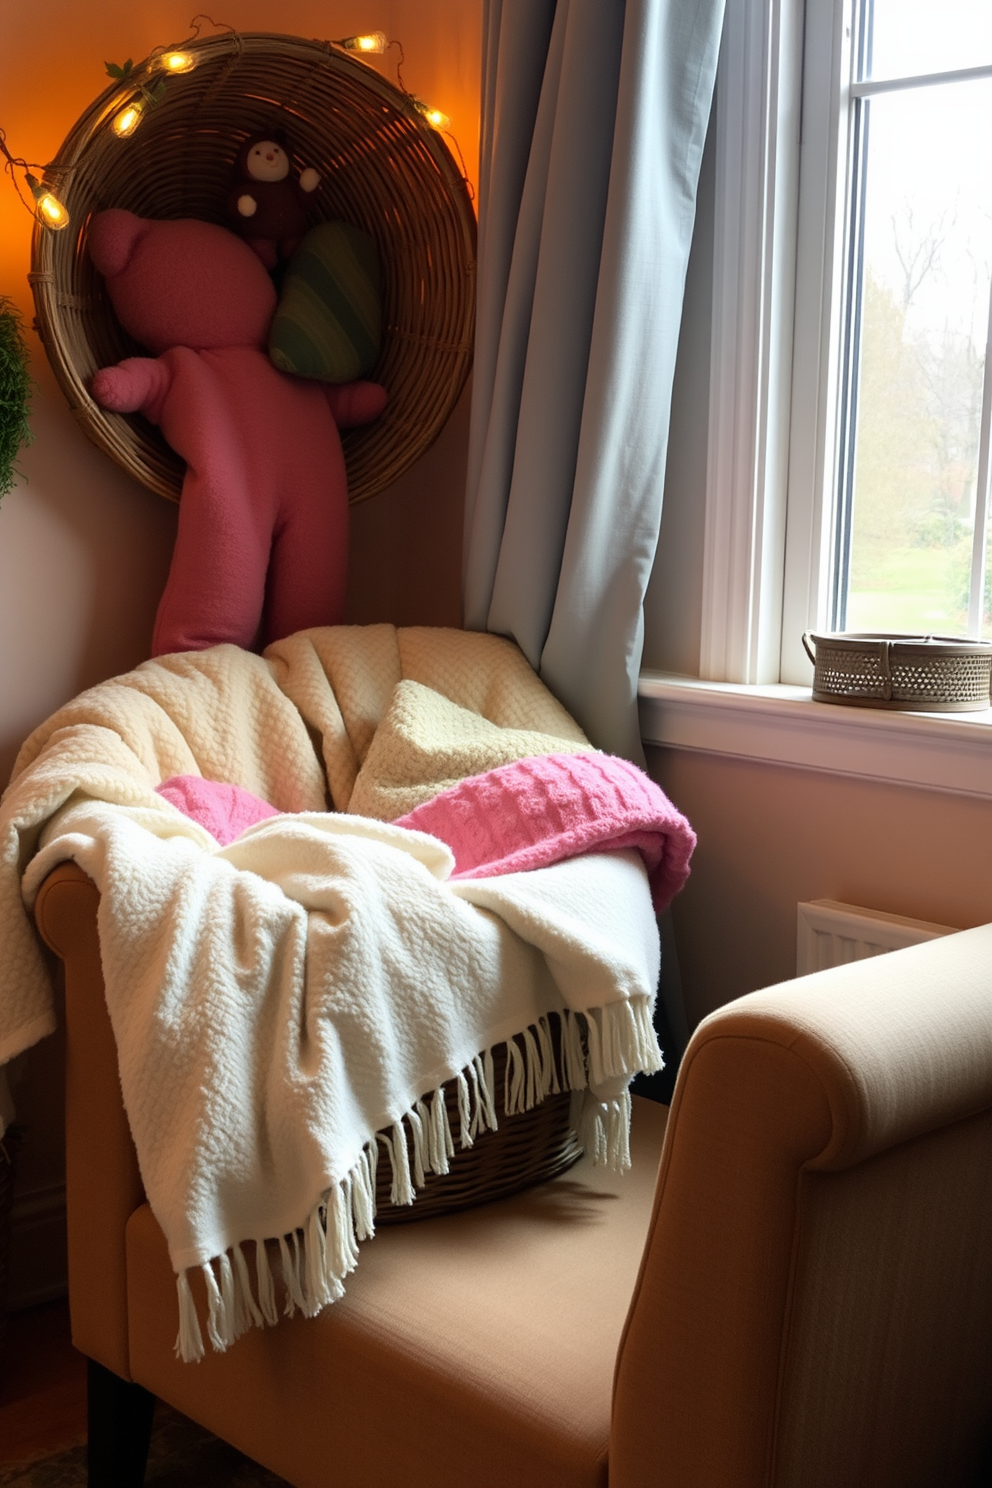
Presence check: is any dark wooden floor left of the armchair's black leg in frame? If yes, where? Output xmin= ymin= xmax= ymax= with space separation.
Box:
xmin=0 ymin=1301 xmax=86 ymax=1472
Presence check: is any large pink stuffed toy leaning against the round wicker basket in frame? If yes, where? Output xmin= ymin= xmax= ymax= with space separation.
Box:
xmin=89 ymin=208 xmax=385 ymax=656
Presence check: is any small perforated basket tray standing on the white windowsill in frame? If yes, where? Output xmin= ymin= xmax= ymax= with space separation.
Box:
xmin=803 ymin=632 xmax=992 ymax=713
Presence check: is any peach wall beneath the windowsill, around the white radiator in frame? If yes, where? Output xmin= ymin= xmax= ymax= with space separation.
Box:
xmin=648 ymin=748 xmax=992 ymax=1028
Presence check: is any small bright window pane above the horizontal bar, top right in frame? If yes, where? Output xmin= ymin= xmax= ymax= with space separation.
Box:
xmin=867 ymin=0 xmax=992 ymax=77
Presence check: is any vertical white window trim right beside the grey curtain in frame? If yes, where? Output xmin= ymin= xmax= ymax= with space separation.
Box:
xmin=699 ymin=0 xmax=803 ymax=683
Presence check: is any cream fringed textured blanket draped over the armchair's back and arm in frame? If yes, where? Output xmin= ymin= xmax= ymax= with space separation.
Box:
xmin=0 ymin=626 xmax=660 ymax=1359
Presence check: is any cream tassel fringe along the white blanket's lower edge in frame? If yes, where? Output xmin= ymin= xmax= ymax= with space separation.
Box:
xmin=175 ymin=998 xmax=662 ymax=1363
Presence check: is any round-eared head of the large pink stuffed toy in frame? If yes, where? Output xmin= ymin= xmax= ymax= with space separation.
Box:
xmin=89 ymin=208 xmax=277 ymax=354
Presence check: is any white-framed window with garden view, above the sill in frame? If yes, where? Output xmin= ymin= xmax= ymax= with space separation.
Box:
xmin=700 ymin=0 xmax=992 ymax=683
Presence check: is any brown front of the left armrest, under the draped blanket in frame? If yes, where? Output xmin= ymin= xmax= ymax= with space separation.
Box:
xmin=34 ymin=863 xmax=144 ymax=1378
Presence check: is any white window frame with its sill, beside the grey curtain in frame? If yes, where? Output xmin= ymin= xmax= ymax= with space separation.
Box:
xmin=640 ymin=0 xmax=992 ymax=799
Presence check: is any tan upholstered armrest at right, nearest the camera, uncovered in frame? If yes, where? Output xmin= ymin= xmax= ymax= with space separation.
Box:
xmin=610 ymin=926 xmax=992 ymax=1488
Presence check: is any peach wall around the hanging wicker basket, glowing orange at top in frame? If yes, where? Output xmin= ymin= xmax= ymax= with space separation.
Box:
xmin=0 ymin=0 xmax=482 ymax=1293
